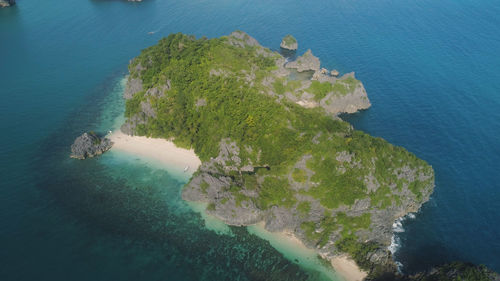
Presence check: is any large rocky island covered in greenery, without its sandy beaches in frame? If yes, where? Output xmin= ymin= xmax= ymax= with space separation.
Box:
xmin=122 ymin=31 xmax=434 ymax=276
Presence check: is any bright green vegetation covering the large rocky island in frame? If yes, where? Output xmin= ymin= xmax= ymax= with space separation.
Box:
xmin=125 ymin=34 xmax=432 ymax=256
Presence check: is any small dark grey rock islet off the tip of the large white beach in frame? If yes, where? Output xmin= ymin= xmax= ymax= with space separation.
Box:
xmin=70 ymin=132 xmax=113 ymax=159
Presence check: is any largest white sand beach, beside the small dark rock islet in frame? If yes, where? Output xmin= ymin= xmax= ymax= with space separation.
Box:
xmin=107 ymin=130 xmax=201 ymax=174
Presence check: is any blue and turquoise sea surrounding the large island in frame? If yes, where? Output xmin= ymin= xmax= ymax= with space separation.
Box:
xmin=0 ymin=0 xmax=500 ymax=280
